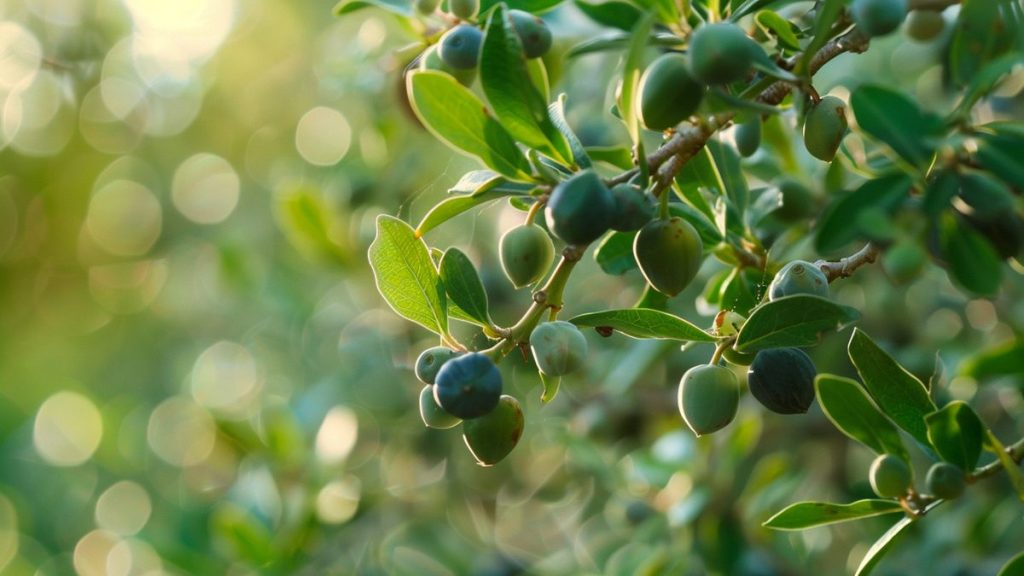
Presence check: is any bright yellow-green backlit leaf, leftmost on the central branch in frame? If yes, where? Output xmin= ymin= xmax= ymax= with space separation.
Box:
xmin=370 ymin=214 xmax=447 ymax=335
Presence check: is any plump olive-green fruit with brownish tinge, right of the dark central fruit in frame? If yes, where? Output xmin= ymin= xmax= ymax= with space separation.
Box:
xmin=633 ymin=216 xmax=703 ymax=296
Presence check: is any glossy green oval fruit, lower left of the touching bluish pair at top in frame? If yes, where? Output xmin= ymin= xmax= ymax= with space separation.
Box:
xmin=637 ymin=52 xmax=705 ymax=130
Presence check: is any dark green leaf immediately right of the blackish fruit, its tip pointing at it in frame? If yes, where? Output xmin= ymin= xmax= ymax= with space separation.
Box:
xmin=814 ymin=374 xmax=910 ymax=461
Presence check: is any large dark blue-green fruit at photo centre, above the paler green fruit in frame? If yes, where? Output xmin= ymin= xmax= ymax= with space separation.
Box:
xmin=544 ymin=169 xmax=615 ymax=245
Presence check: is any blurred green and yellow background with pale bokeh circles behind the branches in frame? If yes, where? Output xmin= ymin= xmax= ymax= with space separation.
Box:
xmin=0 ymin=0 xmax=1024 ymax=576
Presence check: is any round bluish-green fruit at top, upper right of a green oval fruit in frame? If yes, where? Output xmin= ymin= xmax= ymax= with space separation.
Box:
xmin=689 ymin=23 xmax=761 ymax=84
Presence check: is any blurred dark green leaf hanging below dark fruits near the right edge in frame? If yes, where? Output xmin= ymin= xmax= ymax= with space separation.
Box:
xmin=939 ymin=213 xmax=1002 ymax=295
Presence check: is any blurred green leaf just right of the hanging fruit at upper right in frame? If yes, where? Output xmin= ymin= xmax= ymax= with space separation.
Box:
xmin=850 ymin=85 xmax=943 ymax=168
